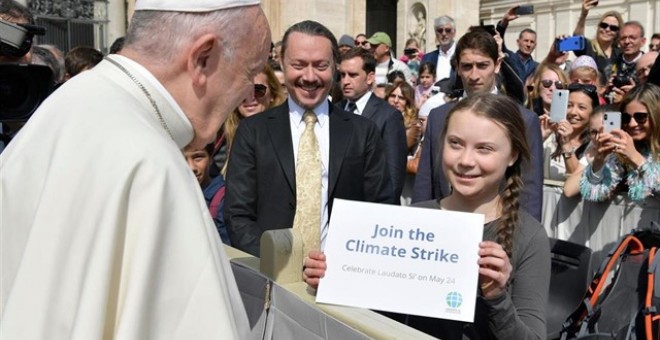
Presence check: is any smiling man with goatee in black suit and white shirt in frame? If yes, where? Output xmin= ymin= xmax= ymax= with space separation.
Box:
xmin=225 ymin=21 xmax=394 ymax=256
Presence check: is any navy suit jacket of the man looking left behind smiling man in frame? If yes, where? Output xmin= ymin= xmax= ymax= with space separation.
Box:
xmin=339 ymin=94 xmax=408 ymax=202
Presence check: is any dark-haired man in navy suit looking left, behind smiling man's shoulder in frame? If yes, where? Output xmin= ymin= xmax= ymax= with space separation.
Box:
xmin=339 ymin=47 xmax=408 ymax=198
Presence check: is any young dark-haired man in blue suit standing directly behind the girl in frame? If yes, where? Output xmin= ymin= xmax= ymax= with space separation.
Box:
xmin=412 ymin=30 xmax=543 ymax=221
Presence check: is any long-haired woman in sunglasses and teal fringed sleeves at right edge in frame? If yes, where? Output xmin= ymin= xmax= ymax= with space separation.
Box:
xmin=580 ymin=83 xmax=660 ymax=201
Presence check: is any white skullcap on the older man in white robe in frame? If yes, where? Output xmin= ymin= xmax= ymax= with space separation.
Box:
xmin=135 ymin=0 xmax=261 ymax=12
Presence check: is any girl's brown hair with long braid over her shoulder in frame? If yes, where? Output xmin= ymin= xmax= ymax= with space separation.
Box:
xmin=441 ymin=93 xmax=530 ymax=257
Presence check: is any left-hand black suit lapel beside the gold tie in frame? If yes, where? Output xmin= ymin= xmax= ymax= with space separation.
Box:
xmin=267 ymin=102 xmax=296 ymax=193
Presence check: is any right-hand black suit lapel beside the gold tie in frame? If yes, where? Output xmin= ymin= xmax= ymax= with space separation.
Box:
xmin=328 ymin=104 xmax=353 ymax=197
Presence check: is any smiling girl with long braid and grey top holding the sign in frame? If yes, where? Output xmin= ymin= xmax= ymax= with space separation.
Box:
xmin=303 ymin=94 xmax=550 ymax=339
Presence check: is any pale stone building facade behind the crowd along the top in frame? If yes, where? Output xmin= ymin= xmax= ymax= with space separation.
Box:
xmin=18 ymin=0 xmax=660 ymax=60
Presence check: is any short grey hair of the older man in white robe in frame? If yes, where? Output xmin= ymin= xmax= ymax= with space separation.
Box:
xmin=124 ymin=7 xmax=250 ymax=64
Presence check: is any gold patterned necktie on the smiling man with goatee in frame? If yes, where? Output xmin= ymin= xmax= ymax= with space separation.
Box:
xmin=293 ymin=110 xmax=323 ymax=256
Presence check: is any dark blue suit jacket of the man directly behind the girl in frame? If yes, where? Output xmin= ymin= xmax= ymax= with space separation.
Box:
xmin=412 ymin=102 xmax=543 ymax=221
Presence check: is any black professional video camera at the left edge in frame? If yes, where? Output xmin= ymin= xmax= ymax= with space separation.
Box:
xmin=0 ymin=19 xmax=54 ymax=122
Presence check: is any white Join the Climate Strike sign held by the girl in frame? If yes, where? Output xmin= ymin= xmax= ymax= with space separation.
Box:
xmin=316 ymin=199 xmax=484 ymax=322
